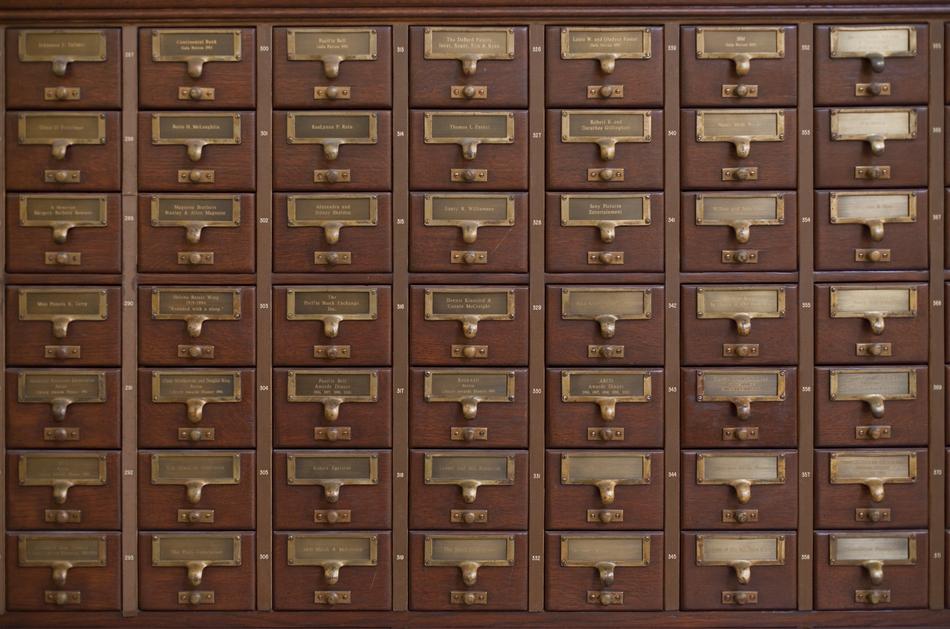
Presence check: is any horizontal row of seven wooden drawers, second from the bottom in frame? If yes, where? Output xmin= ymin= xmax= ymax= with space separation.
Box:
xmin=0 ymin=448 xmax=929 ymax=530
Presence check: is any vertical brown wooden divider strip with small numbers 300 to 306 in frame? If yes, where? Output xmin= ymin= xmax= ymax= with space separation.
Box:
xmin=254 ymin=24 xmax=274 ymax=610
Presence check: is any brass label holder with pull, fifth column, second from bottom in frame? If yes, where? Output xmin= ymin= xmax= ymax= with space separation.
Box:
xmin=561 ymin=452 xmax=652 ymax=505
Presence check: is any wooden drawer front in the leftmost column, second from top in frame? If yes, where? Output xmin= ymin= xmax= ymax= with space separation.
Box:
xmin=6 ymin=111 xmax=122 ymax=192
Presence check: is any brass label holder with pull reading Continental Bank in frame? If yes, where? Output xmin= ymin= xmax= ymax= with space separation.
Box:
xmin=152 ymin=28 xmax=241 ymax=79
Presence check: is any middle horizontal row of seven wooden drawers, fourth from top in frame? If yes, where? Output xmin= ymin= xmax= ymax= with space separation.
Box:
xmin=7 ymin=283 xmax=932 ymax=367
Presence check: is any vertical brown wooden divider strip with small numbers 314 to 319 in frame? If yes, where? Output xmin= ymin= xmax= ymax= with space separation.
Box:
xmin=392 ymin=24 xmax=409 ymax=611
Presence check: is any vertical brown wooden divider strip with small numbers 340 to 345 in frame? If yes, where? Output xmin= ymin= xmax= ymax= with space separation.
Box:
xmin=654 ymin=22 xmax=680 ymax=610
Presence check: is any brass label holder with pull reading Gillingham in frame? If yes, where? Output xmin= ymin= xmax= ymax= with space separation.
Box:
xmin=561 ymin=109 xmax=653 ymax=161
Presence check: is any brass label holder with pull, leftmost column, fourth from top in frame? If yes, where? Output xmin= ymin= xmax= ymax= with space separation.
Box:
xmin=17 ymin=288 xmax=109 ymax=339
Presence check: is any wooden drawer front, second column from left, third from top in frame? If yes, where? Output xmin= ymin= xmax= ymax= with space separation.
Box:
xmin=139 ymin=194 xmax=256 ymax=273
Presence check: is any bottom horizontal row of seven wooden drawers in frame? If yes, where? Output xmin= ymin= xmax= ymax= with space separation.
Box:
xmin=6 ymin=530 xmax=928 ymax=611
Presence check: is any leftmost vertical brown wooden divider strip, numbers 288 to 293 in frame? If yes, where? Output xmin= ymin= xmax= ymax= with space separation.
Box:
xmin=120 ymin=26 xmax=144 ymax=616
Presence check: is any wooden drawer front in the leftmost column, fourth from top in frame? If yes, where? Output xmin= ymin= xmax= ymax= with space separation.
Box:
xmin=6 ymin=286 xmax=122 ymax=367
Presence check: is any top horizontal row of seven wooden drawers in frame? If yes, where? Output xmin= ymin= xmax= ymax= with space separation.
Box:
xmin=7 ymin=24 xmax=950 ymax=109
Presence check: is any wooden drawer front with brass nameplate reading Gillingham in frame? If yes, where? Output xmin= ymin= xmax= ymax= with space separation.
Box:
xmin=546 ymin=109 xmax=664 ymax=190
